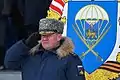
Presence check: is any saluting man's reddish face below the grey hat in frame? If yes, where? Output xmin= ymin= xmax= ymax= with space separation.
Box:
xmin=41 ymin=33 xmax=62 ymax=50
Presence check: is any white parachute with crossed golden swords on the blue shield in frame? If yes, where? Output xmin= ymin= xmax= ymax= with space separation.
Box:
xmin=72 ymin=4 xmax=111 ymax=61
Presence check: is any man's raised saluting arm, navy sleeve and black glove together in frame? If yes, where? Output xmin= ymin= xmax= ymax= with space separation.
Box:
xmin=4 ymin=32 xmax=40 ymax=69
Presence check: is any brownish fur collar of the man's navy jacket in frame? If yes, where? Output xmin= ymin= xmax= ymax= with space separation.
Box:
xmin=30 ymin=37 xmax=74 ymax=58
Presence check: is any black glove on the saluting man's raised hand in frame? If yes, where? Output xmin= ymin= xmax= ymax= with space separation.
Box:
xmin=25 ymin=32 xmax=41 ymax=48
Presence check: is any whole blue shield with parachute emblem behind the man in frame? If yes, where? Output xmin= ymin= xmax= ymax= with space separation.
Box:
xmin=67 ymin=1 xmax=118 ymax=73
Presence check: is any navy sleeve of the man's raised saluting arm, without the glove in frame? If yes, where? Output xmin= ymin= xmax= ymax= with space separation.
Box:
xmin=4 ymin=40 xmax=30 ymax=70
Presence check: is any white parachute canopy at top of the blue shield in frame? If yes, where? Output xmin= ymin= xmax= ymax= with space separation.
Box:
xmin=75 ymin=4 xmax=109 ymax=25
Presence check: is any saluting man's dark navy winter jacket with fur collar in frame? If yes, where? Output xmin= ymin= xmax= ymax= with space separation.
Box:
xmin=4 ymin=38 xmax=85 ymax=80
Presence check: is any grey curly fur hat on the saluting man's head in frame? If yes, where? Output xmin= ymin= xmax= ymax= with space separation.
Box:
xmin=39 ymin=18 xmax=64 ymax=34
